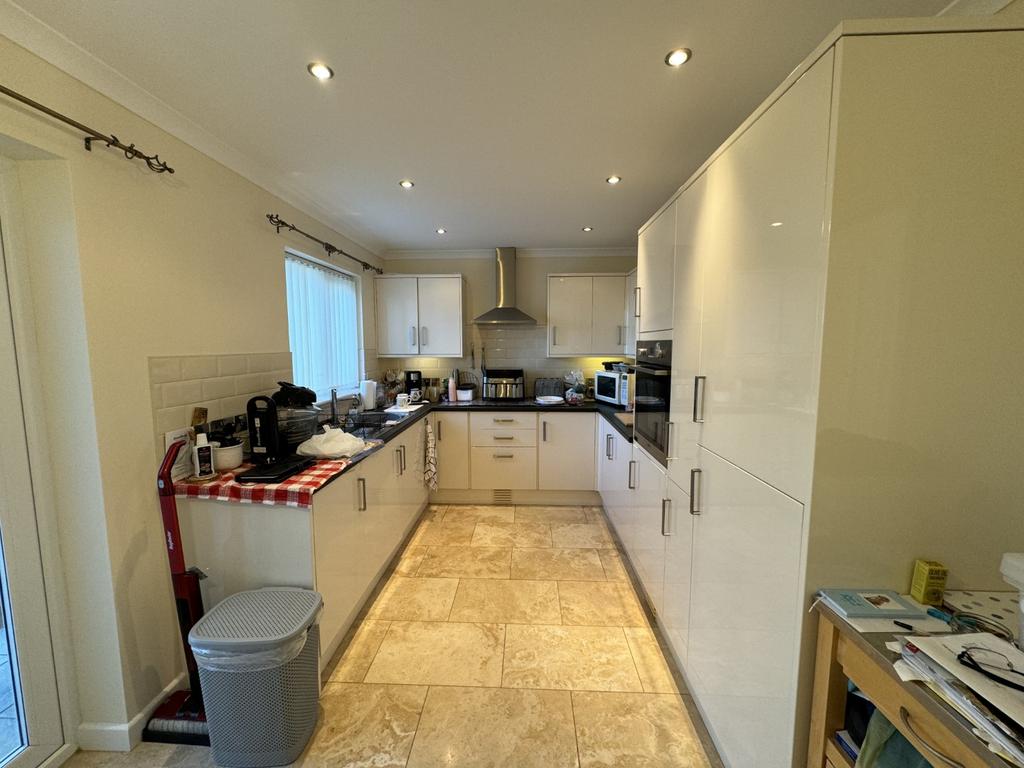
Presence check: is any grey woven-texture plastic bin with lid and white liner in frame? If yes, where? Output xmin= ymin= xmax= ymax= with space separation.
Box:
xmin=188 ymin=587 xmax=324 ymax=768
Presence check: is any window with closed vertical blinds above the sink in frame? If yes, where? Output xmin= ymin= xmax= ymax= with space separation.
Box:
xmin=285 ymin=254 xmax=359 ymax=400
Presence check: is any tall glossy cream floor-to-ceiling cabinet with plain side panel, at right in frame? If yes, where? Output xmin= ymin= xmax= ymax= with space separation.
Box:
xmin=620 ymin=22 xmax=1024 ymax=768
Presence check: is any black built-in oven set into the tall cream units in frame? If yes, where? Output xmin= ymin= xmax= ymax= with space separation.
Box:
xmin=633 ymin=340 xmax=672 ymax=466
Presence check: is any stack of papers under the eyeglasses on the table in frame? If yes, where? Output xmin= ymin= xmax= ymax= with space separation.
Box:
xmin=897 ymin=632 xmax=1024 ymax=766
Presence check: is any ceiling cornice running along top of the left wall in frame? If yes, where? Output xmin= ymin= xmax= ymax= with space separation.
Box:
xmin=0 ymin=0 xmax=384 ymax=257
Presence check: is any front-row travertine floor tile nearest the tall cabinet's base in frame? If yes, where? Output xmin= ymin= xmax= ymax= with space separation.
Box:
xmin=572 ymin=691 xmax=709 ymax=768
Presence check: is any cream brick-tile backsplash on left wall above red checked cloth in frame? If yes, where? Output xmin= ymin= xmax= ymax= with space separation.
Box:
xmin=150 ymin=352 xmax=292 ymax=456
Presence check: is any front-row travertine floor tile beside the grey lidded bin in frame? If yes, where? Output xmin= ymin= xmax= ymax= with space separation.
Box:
xmin=295 ymin=683 xmax=427 ymax=768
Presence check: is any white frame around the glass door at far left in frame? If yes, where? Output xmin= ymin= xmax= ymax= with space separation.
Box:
xmin=0 ymin=156 xmax=78 ymax=768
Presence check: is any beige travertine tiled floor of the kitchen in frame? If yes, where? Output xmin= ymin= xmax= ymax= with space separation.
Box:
xmin=68 ymin=506 xmax=720 ymax=768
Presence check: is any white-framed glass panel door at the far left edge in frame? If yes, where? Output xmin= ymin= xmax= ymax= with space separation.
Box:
xmin=0 ymin=176 xmax=65 ymax=768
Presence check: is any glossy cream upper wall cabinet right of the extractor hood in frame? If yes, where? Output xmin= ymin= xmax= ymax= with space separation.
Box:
xmin=548 ymin=274 xmax=628 ymax=357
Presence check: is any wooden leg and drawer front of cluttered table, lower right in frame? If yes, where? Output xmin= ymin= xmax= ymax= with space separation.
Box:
xmin=807 ymin=603 xmax=1010 ymax=768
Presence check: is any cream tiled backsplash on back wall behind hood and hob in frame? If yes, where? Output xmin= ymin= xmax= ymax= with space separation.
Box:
xmin=379 ymin=325 xmax=632 ymax=396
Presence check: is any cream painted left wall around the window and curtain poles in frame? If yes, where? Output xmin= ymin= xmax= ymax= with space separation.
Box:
xmin=0 ymin=33 xmax=376 ymax=741
